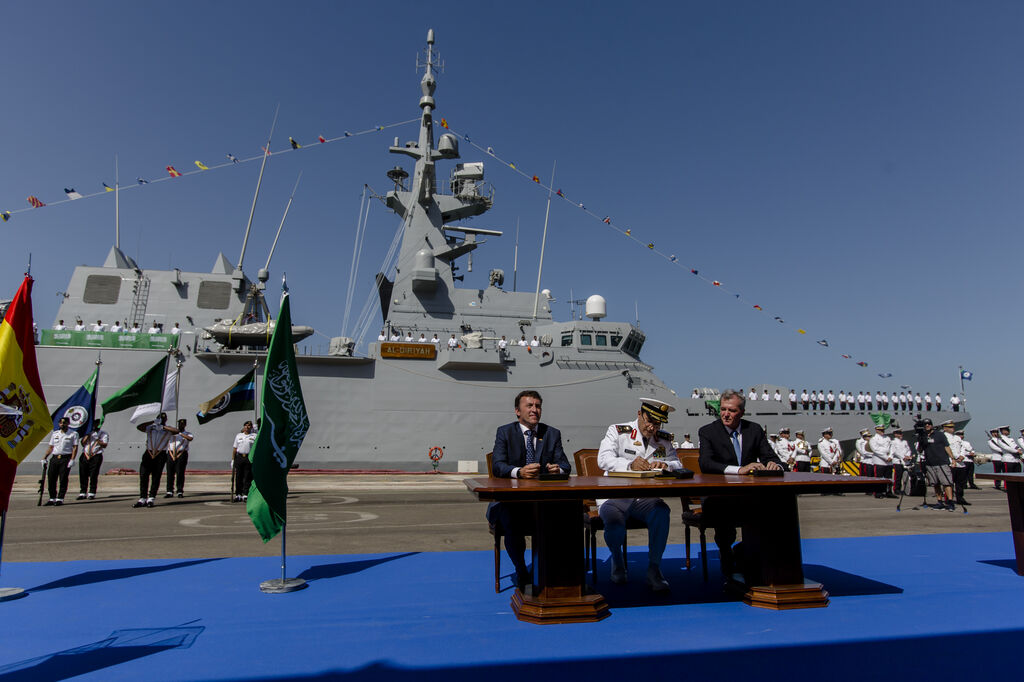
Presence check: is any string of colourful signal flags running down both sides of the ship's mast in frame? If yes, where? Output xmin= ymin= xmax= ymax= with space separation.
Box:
xmin=0 ymin=109 xmax=893 ymax=379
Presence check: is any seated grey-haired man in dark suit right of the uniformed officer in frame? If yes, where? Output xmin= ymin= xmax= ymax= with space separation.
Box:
xmin=697 ymin=390 xmax=784 ymax=578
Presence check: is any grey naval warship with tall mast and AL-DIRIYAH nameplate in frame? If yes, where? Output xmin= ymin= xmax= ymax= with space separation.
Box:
xmin=19 ymin=31 xmax=970 ymax=471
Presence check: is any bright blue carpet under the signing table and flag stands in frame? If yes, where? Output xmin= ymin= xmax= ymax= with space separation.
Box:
xmin=0 ymin=532 xmax=1024 ymax=682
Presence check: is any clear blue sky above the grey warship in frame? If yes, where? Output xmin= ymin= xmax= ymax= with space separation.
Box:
xmin=0 ymin=1 xmax=1024 ymax=447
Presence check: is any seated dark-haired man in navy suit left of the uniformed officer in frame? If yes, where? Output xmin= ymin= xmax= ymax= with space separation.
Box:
xmin=487 ymin=390 xmax=571 ymax=586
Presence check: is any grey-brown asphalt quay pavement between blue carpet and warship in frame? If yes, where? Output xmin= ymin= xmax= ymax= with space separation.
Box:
xmin=2 ymin=471 xmax=1010 ymax=562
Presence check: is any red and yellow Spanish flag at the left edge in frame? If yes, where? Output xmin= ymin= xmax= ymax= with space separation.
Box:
xmin=0 ymin=275 xmax=50 ymax=511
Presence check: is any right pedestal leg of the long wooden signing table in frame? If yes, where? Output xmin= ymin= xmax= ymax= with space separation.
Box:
xmin=743 ymin=494 xmax=828 ymax=609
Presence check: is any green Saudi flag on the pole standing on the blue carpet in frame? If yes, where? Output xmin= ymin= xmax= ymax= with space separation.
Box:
xmin=246 ymin=294 xmax=309 ymax=542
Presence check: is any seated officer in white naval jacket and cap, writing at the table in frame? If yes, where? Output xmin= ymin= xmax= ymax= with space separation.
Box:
xmin=597 ymin=399 xmax=683 ymax=592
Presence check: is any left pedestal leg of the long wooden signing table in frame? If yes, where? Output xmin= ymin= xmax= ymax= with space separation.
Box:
xmin=512 ymin=500 xmax=610 ymax=624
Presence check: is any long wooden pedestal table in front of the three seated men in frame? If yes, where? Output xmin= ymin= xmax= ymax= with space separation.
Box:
xmin=465 ymin=472 xmax=889 ymax=623
